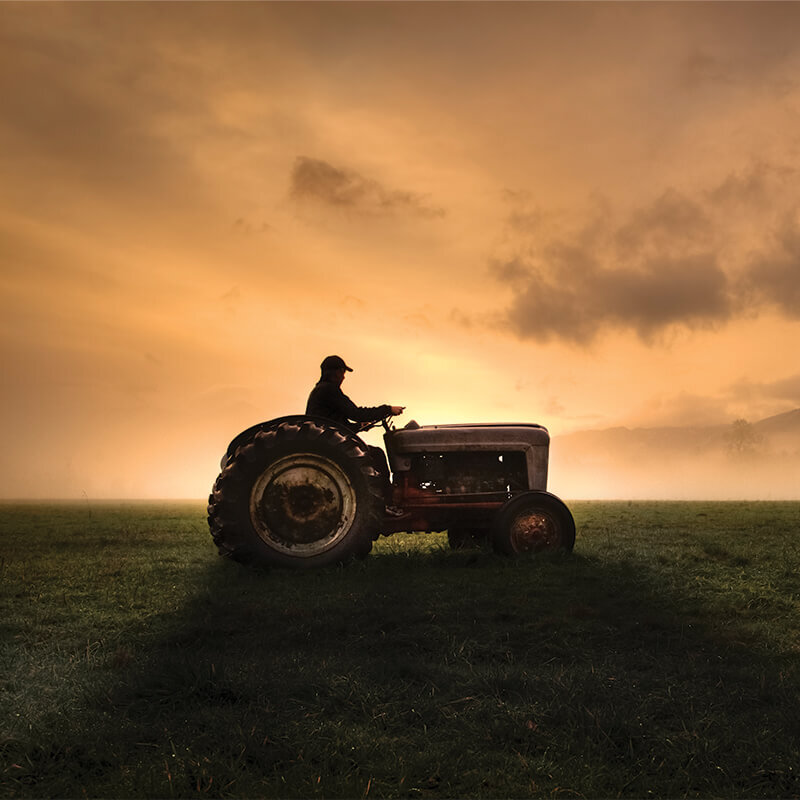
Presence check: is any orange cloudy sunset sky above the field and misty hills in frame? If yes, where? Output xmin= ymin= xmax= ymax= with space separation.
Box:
xmin=0 ymin=2 xmax=800 ymax=499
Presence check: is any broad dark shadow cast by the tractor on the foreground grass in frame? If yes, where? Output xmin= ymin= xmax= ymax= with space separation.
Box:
xmin=86 ymin=549 xmax=800 ymax=797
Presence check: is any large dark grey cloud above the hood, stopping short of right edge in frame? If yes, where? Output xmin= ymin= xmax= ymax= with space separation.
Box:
xmin=491 ymin=189 xmax=732 ymax=344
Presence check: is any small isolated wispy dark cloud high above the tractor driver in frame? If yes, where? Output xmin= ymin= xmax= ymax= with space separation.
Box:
xmin=289 ymin=156 xmax=444 ymax=218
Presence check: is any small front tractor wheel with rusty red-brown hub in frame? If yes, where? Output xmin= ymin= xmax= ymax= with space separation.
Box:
xmin=492 ymin=492 xmax=575 ymax=556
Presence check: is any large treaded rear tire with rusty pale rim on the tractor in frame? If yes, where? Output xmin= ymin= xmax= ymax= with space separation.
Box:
xmin=208 ymin=418 xmax=383 ymax=568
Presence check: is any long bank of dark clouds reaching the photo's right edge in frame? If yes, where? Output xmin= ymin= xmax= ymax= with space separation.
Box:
xmin=489 ymin=162 xmax=800 ymax=345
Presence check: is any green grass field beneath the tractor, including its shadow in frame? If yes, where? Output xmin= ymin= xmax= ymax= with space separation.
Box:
xmin=0 ymin=502 xmax=800 ymax=798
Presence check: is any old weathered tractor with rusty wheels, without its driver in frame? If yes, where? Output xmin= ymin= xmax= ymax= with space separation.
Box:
xmin=208 ymin=415 xmax=575 ymax=568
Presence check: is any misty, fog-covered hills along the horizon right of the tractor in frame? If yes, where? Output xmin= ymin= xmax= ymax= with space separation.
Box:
xmin=549 ymin=409 xmax=800 ymax=500
